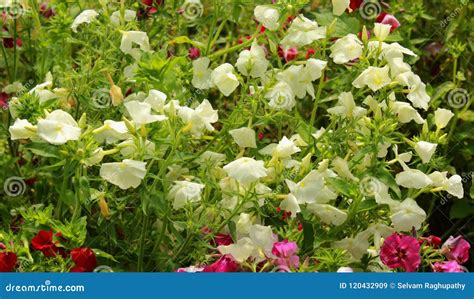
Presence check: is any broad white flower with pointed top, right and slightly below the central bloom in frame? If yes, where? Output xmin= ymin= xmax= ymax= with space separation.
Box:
xmin=285 ymin=170 xmax=337 ymax=204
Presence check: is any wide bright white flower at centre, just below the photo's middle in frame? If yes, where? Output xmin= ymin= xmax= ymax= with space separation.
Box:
xmin=224 ymin=157 xmax=268 ymax=184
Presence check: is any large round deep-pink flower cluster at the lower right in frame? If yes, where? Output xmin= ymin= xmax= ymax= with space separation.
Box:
xmin=380 ymin=233 xmax=421 ymax=272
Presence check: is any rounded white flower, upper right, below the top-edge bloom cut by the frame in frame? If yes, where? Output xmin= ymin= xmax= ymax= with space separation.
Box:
xmin=329 ymin=34 xmax=363 ymax=64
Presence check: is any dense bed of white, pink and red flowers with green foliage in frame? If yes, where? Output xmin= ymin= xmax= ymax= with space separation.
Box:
xmin=0 ymin=0 xmax=472 ymax=272
